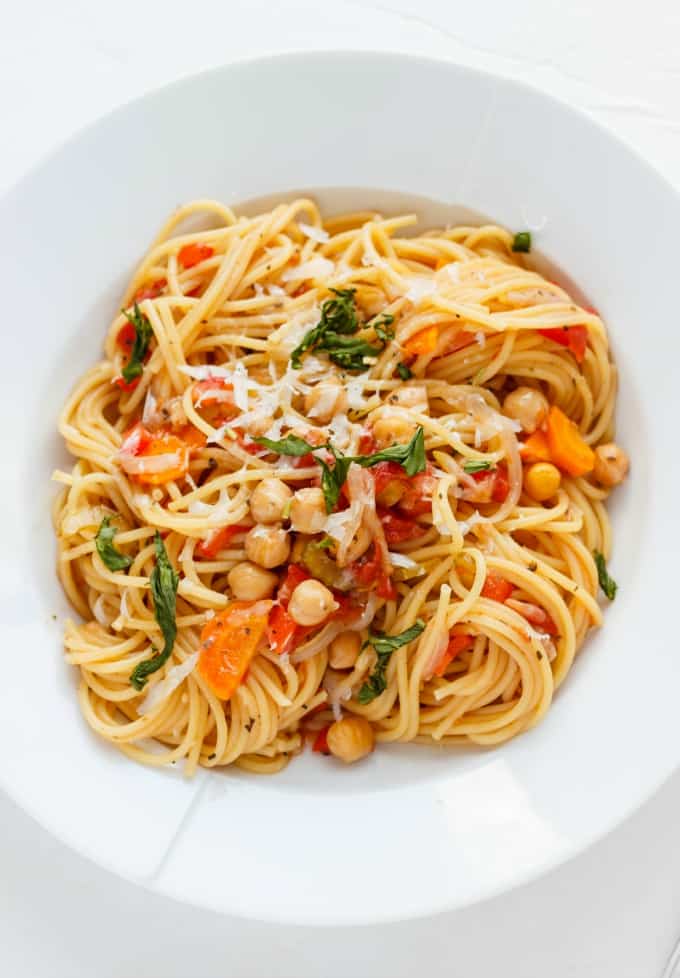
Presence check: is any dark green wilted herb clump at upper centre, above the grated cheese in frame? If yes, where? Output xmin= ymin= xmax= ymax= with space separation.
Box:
xmin=290 ymin=289 xmax=394 ymax=371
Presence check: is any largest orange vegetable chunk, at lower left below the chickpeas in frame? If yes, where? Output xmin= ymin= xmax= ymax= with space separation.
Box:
xmin=198 ymin=601 xmax=272 ymax=700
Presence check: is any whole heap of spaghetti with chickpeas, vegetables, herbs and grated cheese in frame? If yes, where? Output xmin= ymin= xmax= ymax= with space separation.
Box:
xmin=54 ymin=199 xmax=627 ymax=774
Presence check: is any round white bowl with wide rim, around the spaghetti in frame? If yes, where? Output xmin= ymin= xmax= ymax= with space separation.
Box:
xmin=0 ymin=53 xmax=680 ymax=924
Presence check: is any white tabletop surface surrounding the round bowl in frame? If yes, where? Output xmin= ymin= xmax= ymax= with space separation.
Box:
xmin=0 ymin=0 xmax=680 ymax=978
